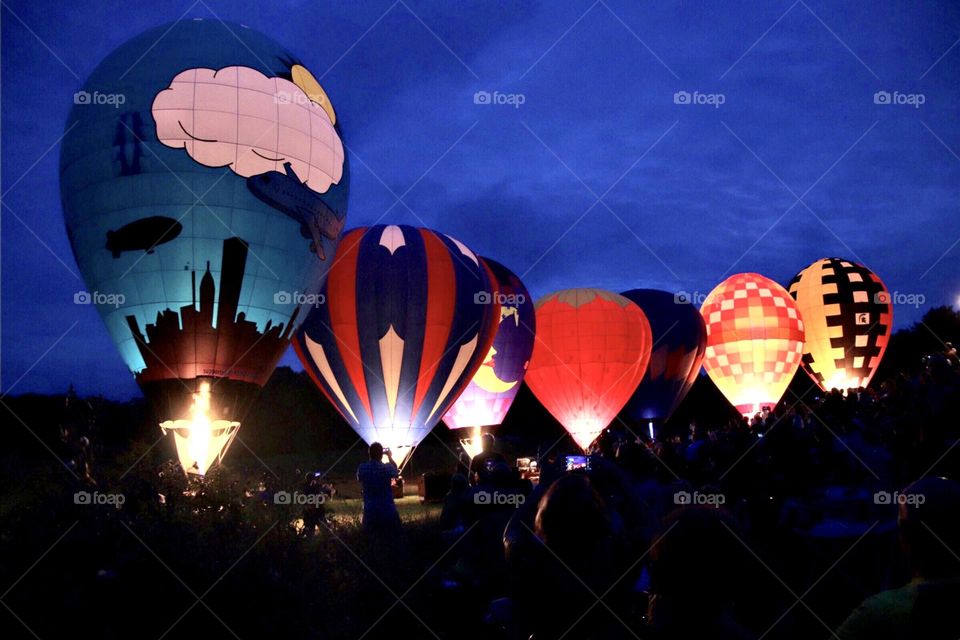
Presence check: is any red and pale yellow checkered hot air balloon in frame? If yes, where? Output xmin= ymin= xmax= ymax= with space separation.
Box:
xmin=700 ymin=273 xmax=803 ymax=416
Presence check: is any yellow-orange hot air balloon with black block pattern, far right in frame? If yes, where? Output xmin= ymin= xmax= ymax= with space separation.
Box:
xmin=788 ymin=258 xmax=893 ymax=391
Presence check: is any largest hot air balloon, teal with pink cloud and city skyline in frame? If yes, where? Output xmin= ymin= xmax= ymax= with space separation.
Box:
xmin=60 ymin=20 xmax=349 ymax=474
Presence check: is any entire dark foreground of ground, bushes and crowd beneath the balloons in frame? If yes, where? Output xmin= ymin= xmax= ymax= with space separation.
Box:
xmin=0 ymin=350 xmax=960 ymax=640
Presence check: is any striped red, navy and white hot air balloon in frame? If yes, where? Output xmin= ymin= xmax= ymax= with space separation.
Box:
xmin=294 ymin=225 xmax=500 ymax=466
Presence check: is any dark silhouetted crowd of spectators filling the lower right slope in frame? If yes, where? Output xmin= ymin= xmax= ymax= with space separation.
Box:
xmin=418 ymin=354 xmax=960 ymax=640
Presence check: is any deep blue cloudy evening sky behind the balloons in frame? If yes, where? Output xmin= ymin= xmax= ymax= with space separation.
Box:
xmin=0 ymin=0 xmax=960 ymax=398
